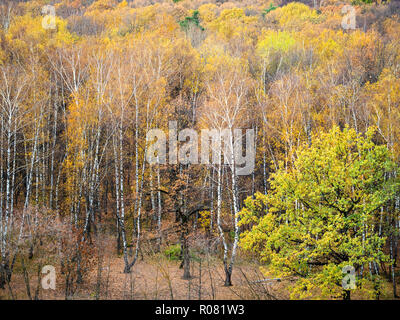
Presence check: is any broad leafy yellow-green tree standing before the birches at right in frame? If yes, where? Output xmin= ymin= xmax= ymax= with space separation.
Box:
xmin=240 ymin=127 xmax=398 ymax=299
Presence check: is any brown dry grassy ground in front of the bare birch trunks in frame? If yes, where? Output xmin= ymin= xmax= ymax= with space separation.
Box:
xmin=0 ymin=242 xmax=287 ymax=300
